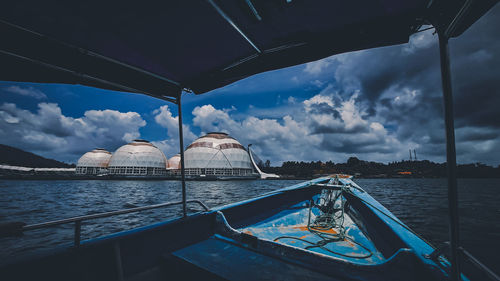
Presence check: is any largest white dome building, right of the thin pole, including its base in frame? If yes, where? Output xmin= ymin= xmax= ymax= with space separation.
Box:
xmin=184 ymin=132 xmax=256 ymax=178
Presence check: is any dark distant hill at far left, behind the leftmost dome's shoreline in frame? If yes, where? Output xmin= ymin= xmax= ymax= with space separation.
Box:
xmin=0 ymin=144 xmax=75 ymax=168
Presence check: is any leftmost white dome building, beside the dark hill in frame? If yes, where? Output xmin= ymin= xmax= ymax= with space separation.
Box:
xmin=75 ymin=148 xmax=111 ymax=175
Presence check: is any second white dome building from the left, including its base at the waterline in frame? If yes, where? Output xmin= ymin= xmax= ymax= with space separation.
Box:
xmin=108 ymin=140 xmax=167 ymax=177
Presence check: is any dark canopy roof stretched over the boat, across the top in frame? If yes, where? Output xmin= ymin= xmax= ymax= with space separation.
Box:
xmin=0 ymin=0 xmax=497 ymax=98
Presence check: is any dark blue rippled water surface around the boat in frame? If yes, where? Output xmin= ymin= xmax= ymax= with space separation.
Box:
xmin=0 ymin=179 xmax=500 ymax=272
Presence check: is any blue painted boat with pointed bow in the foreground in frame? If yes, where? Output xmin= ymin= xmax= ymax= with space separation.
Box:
xmin=0 ymin=178 xmax=468 ymax=280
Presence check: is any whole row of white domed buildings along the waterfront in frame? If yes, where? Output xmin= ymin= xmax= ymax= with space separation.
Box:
xmin=75 ymin=135 xmax=278 ymax=180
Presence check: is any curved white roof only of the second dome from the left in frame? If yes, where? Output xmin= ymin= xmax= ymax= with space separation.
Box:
xmin=109 ymin=140 xmax=167 ymax=169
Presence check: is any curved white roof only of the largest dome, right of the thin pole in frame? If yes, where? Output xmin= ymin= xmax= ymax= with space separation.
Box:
xmin=184 ymin=132 xmax=253 ymax=169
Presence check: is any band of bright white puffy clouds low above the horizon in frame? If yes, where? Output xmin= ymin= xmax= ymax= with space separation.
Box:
xmin=0 ymin=96 xmax=500 ymax=165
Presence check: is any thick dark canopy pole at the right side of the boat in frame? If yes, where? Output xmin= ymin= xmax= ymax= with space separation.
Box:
xmin=438 ymin=32 xmax=460 ymax=281
